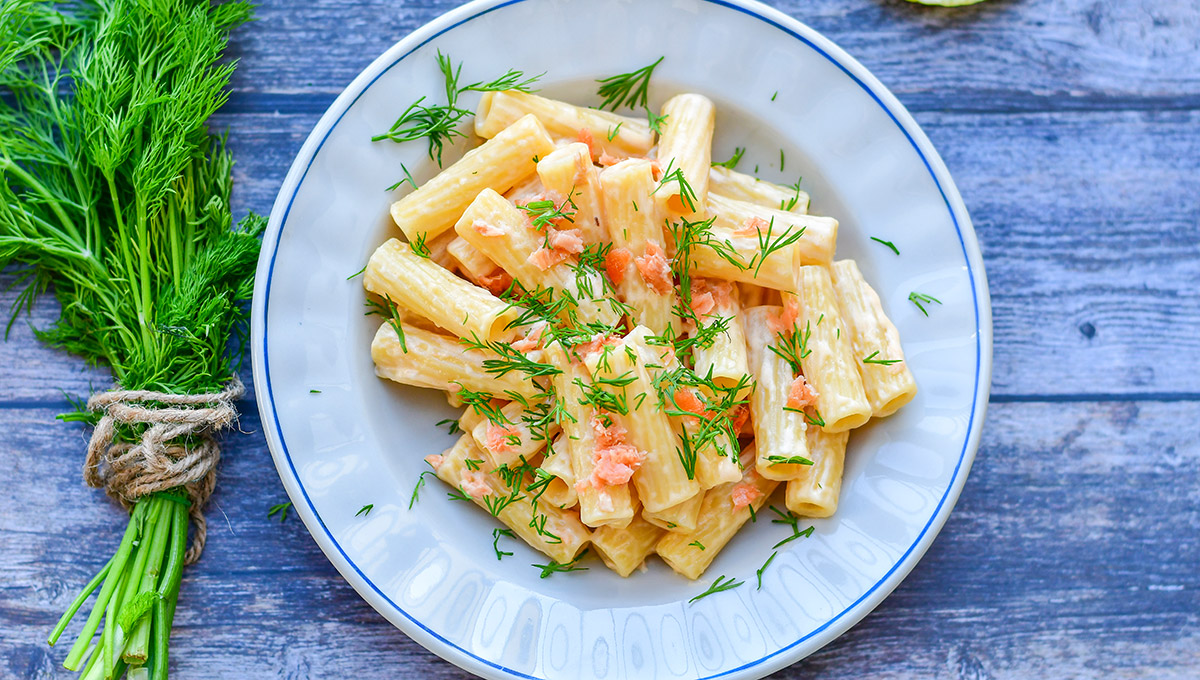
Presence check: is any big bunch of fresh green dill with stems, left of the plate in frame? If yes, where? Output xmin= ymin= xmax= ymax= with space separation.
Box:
xmin=0 ymin=0 xmax=265 ymax=678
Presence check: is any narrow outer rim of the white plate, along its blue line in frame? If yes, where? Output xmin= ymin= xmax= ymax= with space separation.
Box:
xmin=252 ymin=0 xmax=991 ymax=680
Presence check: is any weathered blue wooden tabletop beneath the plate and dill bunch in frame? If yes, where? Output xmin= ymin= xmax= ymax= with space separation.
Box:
xmin=0 ymin=0 xmax=1200 ymax=680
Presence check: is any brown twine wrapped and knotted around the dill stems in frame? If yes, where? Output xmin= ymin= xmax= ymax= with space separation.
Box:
xmin=83 ymin=375 xmax=246 ymax=564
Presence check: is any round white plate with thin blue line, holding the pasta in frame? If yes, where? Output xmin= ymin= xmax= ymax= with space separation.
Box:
xmin=253 ymin=0 xmax=991 ymax=680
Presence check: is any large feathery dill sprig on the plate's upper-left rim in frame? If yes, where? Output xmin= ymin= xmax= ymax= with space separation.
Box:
xmin=371 ymin=50 xmax=541 ymax=165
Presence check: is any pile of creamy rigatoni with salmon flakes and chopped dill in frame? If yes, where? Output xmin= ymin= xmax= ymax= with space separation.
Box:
xmin=365 ymin=78 xmax=917 ymax=579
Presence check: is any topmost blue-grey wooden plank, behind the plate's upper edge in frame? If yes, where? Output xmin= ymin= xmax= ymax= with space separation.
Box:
xmin=218 ymin=0 xmax=1200 ymax=110
